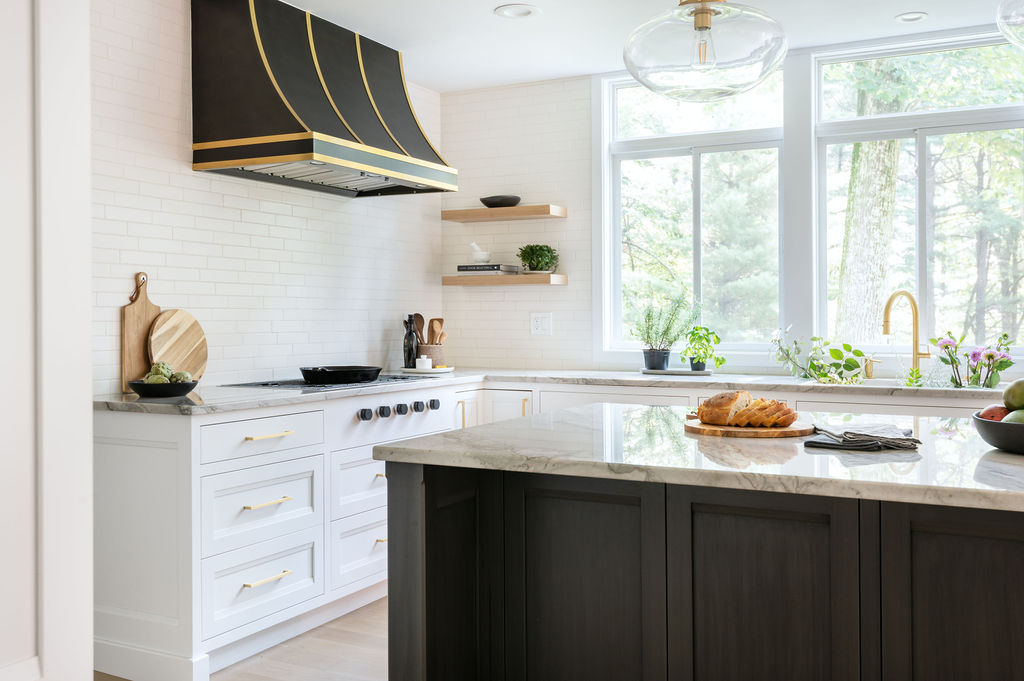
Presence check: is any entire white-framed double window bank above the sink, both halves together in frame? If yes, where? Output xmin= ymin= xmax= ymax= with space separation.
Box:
xmin=595 ymin=34 xmax=1024 ymax=374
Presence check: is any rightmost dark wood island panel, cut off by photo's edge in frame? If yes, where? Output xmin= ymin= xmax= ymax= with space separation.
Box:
xmin=882 ymin=503 xmax=1024 ymax=681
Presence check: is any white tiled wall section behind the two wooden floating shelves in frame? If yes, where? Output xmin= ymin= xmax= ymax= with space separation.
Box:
xmin=441 ymin=77 xmax=596 ymax=369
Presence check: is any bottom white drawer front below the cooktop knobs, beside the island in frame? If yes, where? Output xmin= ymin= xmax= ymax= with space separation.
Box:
xmin=331 ymin=508 xmax=387 ymax=589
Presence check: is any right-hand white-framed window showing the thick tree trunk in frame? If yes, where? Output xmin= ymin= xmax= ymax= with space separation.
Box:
xmin=818 ymin=45 xmax=1024 ymax=347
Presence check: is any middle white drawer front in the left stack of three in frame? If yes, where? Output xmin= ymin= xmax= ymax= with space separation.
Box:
xmin=201 ymin=456 xmax=324 ymax=557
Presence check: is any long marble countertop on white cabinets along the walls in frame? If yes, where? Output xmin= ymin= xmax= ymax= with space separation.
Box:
xmin=93 ymin=369 xmax=1001 ymax=416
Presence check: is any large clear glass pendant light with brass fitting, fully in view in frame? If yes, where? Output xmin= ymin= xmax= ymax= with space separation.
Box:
xmin=623 ymin=0 xmax=782 ymax=101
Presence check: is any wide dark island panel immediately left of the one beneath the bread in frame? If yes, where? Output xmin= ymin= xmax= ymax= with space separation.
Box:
xmin=505 ymin=473 xmax=666 ymax=681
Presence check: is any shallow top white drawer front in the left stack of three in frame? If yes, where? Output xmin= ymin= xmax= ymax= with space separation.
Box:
xmin=200 ymin=412 xmax=324 ymax=464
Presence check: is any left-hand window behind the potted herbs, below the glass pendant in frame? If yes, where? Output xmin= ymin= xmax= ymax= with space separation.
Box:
xmin=607 ymin=76 xmax=782 ymax=348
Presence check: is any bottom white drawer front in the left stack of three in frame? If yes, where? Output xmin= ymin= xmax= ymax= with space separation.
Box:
xmin=202 ymin=527 xmax=324 ymax=639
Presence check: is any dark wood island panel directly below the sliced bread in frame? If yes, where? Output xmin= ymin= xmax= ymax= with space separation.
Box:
xmin=666 ymin=485 xmax=860 ymax=681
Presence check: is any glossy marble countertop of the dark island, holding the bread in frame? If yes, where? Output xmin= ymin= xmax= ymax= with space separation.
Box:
xmin=374 ymin=403 xmax=1024 ymax=511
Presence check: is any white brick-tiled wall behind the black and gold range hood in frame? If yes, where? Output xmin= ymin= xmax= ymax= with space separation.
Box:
xmin=92 ymin=0 xmax=443 ymax=393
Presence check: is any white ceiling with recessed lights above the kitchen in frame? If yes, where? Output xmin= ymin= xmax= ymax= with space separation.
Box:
xmin=288 ymin=0 xmax=997 ymax=92
